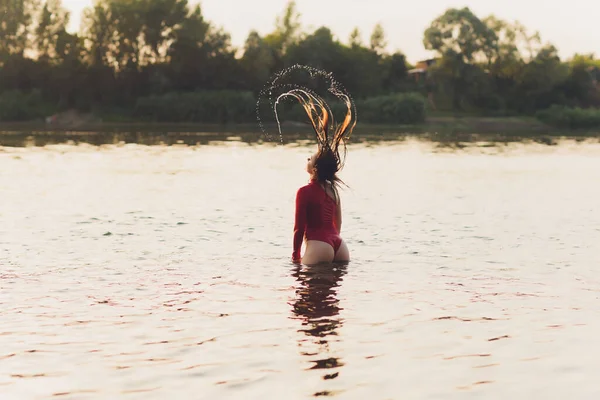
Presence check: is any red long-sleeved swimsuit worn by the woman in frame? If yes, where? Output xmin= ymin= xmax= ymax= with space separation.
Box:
xmin=292 ymin=180 xmax=342 ymax=260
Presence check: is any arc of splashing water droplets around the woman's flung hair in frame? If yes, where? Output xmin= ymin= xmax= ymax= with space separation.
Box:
xmin=256 ymin=65 xmax=357 ymax=148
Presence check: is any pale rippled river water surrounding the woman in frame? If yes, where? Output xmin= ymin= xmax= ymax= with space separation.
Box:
xmin=0 ymin=136 xmax=600 ymax=399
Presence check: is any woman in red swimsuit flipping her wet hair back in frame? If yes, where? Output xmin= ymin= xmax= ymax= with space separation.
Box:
xmin=288 ymin=90 xmax=356 ymax=265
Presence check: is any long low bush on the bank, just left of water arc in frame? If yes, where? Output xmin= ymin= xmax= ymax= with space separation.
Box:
xmin=134 ymin=91 xmax=256 ymax=123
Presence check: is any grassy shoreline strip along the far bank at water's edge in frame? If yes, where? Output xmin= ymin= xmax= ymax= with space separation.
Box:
xmin=0 ymin=116 xmax=600 ymax=141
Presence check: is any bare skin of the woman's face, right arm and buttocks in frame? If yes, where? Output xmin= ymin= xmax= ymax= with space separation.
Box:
xmin=302 ymin=154 xmax=350 ymax=265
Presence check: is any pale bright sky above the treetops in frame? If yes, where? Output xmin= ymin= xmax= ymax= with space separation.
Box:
xmin=63 ymin=0 xmax=600 ymax=63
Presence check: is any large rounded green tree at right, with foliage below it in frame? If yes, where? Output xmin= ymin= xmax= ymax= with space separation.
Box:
xmin=423 ymin=8 xmax=600 ymax=115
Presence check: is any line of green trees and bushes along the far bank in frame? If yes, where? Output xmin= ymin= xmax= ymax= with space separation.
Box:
xmin=0 ymin=0 xmax=600 ymax=126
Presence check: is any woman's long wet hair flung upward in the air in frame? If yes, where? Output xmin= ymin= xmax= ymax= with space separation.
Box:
xmin=288 ymin=89 xmax=356 ymax=202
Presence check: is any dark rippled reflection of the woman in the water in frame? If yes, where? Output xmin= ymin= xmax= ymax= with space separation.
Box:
xmin=291 ymin=264 xmax=347 ymax=379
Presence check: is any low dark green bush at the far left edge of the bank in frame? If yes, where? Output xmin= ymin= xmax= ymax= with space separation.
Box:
xmin=0 ymin=90 xmax=49 ymax=122
